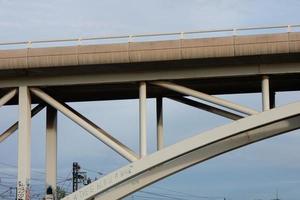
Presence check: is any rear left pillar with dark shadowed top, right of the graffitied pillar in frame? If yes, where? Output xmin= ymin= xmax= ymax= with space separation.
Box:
xmin=46 ymin=106 xmax=57 ymax=195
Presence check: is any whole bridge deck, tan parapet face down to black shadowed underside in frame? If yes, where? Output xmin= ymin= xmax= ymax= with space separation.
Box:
xmin=0 ymin=32 xmax=300 ymax=103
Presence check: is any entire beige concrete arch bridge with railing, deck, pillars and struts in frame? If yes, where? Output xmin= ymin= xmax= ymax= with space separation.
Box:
xmin=0 ymin=25 xmax=300 ymax=200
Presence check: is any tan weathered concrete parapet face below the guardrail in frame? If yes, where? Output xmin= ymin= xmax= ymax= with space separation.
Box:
xmin=0 ymin=33 xmax=300 ymax=70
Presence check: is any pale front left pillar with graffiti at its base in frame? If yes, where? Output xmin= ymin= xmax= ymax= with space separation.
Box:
xmin=17 ymin=86 xmax=31 ymax=200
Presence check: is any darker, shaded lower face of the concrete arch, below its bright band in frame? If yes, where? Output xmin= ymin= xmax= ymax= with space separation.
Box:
xmin=95 ymin=117 xmax=300 ymax=200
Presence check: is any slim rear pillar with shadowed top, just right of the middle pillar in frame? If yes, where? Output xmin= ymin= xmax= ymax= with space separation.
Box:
xmin=156 ymin=97 xmax=164 ymax=151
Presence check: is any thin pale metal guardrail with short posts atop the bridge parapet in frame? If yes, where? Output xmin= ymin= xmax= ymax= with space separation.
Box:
xmin=0 ymin=24 xmax=300 ymax=48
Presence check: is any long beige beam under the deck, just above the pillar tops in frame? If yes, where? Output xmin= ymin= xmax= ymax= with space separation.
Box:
xmin=0 ymin=62 xmax=300 ymax=88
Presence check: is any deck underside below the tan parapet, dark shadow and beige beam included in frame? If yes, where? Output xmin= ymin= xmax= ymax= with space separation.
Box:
xmin=0 ymin=54 xmax=300 ymax=104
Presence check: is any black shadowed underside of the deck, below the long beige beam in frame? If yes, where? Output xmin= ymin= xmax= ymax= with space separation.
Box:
xmin=0 ymin=73 xmax=300 ymax=104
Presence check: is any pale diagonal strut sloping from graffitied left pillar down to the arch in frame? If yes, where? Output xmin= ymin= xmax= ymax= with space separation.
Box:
xmin=30 ymin=88 xmax=138 ymax=161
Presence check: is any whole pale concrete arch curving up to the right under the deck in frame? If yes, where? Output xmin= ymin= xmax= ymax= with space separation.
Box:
xmin=64 ymin=102 xmax=300 ymax=200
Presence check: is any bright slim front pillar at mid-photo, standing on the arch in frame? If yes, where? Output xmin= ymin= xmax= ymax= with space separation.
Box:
xmin=139 ymin=82 xmax=147 ymax=158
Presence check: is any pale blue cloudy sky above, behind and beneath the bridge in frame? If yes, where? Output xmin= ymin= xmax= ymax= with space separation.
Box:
xmin=0 ymin=0 xmax=300 ymax=200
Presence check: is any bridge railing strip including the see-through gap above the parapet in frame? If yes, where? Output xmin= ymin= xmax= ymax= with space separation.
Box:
xmin=0 ymin=24 xmax=300 ymax=49
